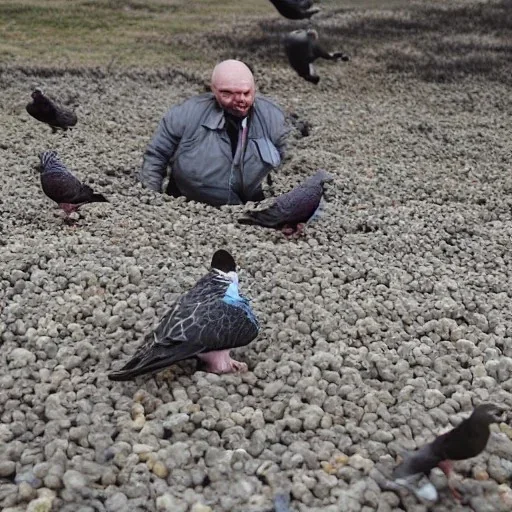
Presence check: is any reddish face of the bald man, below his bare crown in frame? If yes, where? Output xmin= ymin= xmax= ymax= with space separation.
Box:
xmin=212 ymin=75 xmax=255 ymax=117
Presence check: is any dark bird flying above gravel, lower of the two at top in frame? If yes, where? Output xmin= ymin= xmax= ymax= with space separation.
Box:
xmin=284 ymin=29 xmax=350 ymax=85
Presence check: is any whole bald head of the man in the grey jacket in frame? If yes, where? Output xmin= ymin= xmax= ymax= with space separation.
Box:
xmin=212 ymin=59 xmax=256 ymax=117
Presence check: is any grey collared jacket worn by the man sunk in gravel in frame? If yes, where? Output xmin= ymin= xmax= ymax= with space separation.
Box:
xmin=139 ymin=93 xmax=288 ymax=206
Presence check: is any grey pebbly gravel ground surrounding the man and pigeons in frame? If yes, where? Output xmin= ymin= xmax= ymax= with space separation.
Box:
xmin=0 ymin=3 xmax=512 ymax=512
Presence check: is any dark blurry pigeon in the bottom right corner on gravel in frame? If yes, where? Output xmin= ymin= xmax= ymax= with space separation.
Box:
xmin=393 ymin=404 xmax=503 ymax=500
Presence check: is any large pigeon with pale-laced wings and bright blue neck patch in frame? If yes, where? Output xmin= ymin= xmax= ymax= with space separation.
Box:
xmin=109 ymin=249 xmax=259 ymax=381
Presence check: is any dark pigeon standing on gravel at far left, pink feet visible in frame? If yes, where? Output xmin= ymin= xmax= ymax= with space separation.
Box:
xmin=39 ymin=151 xmax=108 ymax=220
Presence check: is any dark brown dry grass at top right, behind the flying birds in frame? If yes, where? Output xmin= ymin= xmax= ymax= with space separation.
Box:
xmin=208 ymin=0 xmax=512 ymax=83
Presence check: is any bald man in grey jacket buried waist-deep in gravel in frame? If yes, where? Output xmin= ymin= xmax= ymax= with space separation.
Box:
xmin=139 ymin=60 xmax=288 ymax=206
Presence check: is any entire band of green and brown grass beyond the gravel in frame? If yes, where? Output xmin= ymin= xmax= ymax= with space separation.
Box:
xmin=0 ymin=0 xmax=512 ymax=83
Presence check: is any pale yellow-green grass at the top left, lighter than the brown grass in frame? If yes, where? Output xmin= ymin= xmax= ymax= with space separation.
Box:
xmin=0 ymin=0 xmax=408 ymax=67
